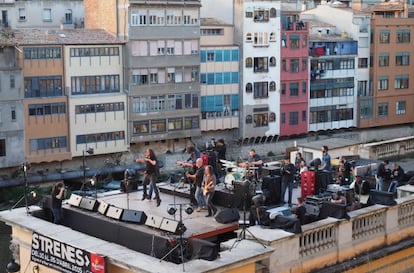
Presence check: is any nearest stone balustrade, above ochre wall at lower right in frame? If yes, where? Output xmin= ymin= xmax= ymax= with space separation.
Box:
xmin=252 ymin=192 xmax=414 ymax=272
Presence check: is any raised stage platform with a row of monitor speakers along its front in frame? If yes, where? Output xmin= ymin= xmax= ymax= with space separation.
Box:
xmin=39 ymin=182 xmax=240 ymax=263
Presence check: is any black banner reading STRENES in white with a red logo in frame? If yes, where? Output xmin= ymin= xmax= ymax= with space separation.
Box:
xmin=31 ymin=232 xmax=106 ymax=273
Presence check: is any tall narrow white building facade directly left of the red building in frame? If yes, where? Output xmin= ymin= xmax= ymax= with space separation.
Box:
xmin=234 ymin=0 xmax=281 ymax=139
